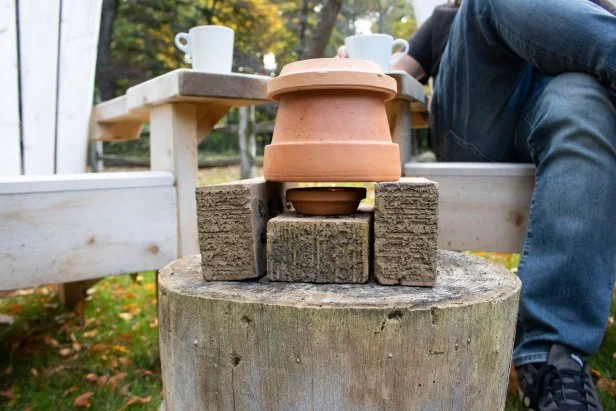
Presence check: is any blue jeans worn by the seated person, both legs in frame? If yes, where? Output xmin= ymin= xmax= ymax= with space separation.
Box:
xmin=432 ymin=0 xmax=616 ymax=365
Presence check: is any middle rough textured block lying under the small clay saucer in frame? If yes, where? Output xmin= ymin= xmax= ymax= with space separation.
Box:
xmin=267 ymin=212 xmax=372 ymax=283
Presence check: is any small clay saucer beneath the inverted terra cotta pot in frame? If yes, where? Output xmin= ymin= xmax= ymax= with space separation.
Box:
xmin=287 ymin=187 xmax=366 ymax=215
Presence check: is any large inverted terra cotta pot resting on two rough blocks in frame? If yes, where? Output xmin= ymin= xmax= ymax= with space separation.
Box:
xmin=263 ymin=58 xmax=400 ymax=182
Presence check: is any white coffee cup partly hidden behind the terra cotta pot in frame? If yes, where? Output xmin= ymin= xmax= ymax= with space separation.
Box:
xmin=344 ymin=34 xmax=409 ymax=71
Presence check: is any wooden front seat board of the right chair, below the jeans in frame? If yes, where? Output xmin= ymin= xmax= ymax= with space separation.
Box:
xmin=405 ymin=163 xmax=535 ymax=253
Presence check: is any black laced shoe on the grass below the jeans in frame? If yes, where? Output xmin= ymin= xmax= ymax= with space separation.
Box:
xmin=516 ymin=344 xmax=603 ymax=411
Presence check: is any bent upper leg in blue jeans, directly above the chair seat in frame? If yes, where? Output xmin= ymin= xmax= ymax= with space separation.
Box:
xmin=433 ymin=0 xmax=616 ymax=161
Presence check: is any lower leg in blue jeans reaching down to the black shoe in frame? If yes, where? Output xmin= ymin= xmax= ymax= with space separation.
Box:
xmin=513 ymin=73 xmax=616 ymax=365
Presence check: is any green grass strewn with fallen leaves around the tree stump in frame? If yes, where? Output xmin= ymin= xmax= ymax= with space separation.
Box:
xmin=0 ymin=167 xmax=616 ymax=411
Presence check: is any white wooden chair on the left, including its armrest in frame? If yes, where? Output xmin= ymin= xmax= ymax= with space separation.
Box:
xmin=0 ymin=0 xmax=268 ymax=302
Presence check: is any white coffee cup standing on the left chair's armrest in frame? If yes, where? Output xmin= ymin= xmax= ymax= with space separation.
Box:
xmin=175 ymin=26 xmax=234 ymax=73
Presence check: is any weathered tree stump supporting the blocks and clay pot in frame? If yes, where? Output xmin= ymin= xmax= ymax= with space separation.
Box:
xmin=159 ymin=251 xmax=520 ymax=411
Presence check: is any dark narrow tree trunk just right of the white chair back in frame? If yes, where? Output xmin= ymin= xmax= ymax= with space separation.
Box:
xmin=96 ymin=0 xmax=118 ymax=101
